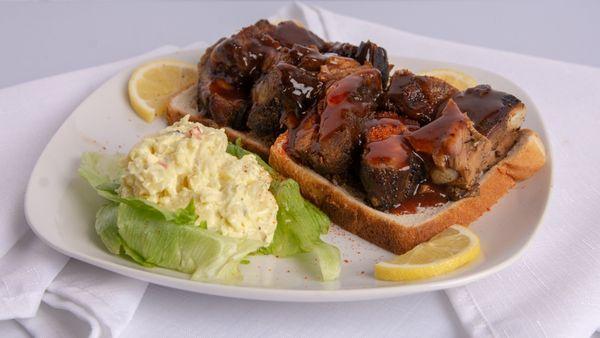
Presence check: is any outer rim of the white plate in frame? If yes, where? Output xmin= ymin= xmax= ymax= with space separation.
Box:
xmin=24 ymin=48 xmax=554 ymax=302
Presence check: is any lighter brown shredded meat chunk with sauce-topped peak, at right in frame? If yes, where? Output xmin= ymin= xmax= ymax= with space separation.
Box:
xmin=406 ymin=99 xmax=492 ymax=190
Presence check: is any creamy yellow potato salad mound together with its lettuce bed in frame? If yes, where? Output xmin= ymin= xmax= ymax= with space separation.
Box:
xmin=79 ymin=117 xmax=340 ymax=283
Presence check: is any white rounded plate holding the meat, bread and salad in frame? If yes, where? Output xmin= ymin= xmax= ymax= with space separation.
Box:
xmin=25 ymin=51 xmax=551 ymax=302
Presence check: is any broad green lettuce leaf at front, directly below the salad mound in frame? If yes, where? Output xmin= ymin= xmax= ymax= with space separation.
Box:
xmin=117 ymin=203 xmax=264 ymax=283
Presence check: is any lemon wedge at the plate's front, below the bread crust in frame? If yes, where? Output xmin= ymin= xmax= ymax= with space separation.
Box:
xmin=375 ymin=225 xmax=481 ymax=281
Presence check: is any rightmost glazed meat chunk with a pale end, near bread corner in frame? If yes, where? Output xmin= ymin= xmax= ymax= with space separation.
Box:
xmin=453 ymin=85 xmax=525 ymax=169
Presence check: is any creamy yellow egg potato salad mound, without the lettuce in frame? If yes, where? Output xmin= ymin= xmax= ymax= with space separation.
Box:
xmin=119 ymin=117 xmax=278 ymax=244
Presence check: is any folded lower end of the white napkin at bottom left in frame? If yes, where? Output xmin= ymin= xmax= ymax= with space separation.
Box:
xmin=19 ymin=260 xmax=147 ymax=337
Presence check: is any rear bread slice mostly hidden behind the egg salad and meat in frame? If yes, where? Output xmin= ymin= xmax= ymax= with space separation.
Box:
xmin=166 ymin=85 xmax=273 ymax=161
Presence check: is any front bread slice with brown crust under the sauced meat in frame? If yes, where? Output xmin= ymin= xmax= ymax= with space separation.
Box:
xmin=269 ymin=129 xmax=546 ymax=254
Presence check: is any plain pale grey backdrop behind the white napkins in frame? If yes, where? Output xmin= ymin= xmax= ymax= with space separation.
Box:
xmin=0 ymin=1 xmax=600 ymax=88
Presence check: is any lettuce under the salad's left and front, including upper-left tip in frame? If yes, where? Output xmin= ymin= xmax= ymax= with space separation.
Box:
xmin=79 ymin=153 xmax=264 ymax=283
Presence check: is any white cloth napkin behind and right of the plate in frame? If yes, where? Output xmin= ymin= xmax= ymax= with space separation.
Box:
xmin=279 ymin=4 xmax=600 ymax=337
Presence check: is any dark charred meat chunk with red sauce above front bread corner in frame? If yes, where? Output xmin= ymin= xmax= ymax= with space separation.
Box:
xmin=360 ymin=114 xmax=426 ymax=210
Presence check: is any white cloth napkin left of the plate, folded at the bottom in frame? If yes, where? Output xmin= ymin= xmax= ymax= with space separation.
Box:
xmin=0 ymin=46 xmax=177 ymax=337
